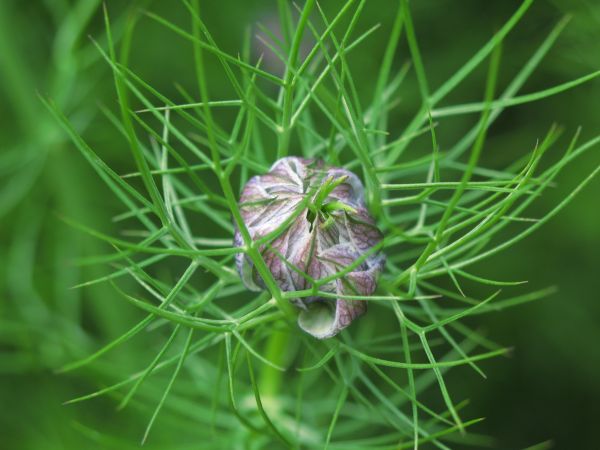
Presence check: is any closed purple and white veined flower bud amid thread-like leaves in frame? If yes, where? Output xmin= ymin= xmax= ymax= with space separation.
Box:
xmin=234 ymin=157 xmax=385 ymax=339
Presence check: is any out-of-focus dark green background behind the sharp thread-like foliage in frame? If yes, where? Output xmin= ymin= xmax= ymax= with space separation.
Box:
xmin=0 ymin=0 xmax=600 ymax=449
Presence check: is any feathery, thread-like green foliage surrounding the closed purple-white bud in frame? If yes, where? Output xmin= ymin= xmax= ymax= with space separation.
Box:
xmin=39 ymin=0 xmax=600 ymax=449
